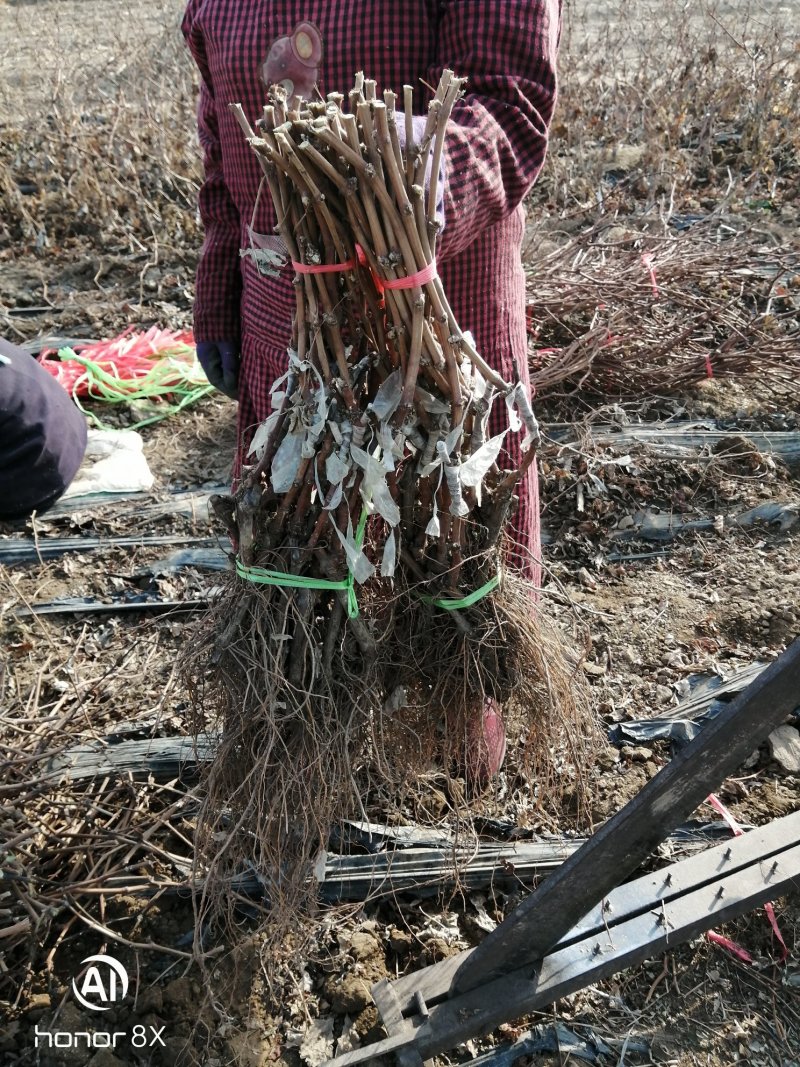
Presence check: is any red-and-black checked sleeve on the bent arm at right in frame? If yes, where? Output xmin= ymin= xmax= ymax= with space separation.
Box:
xmin=428 ymin=0 xmax=561 ymax=262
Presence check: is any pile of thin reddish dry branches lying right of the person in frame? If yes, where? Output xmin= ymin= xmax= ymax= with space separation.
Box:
xmin=528 ymin=219 xmax=800 ymax=399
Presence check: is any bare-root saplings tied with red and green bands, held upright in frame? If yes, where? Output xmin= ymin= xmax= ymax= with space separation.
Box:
xmin=189 ymin=70 xmax=583 ymax=947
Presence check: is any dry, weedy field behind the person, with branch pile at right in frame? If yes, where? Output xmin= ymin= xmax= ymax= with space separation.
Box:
xmin=0 ymin=0 xmax=800 ymax=398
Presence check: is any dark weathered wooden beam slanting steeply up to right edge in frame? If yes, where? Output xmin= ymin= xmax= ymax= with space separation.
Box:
xmin=453 ymin=639 xmax=800 ymax=992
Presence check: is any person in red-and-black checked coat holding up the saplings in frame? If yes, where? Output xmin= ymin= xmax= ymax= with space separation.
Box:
xmin=182 ymin=0 xmax=561 ymax=774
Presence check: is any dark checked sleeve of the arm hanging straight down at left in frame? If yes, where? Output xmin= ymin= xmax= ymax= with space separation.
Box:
xmin=181 ymin=2 xmax=242 ymax=341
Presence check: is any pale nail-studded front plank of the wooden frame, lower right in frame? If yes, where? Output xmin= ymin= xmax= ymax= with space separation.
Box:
xmin=327 ymin=816 xmax=800 ymax=1067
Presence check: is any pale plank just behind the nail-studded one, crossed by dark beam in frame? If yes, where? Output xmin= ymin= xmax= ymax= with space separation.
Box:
xmin=388 ymin=812 xmax=800 ymax=1015
